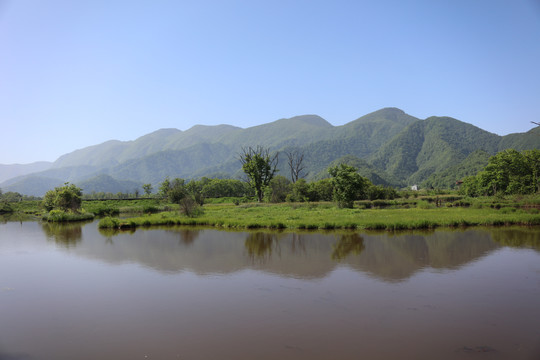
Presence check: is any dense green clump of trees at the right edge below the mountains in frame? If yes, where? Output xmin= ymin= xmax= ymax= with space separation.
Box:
xmin=460 ymin=149 xmax=540 ymax=197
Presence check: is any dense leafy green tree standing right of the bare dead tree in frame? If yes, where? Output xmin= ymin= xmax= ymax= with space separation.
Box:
xmin=328 ymin=164 xmax=369 ymax=208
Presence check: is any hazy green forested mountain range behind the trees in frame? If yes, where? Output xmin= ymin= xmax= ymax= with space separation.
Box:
xmin=0 ymin=108 xmax=540 ymax=196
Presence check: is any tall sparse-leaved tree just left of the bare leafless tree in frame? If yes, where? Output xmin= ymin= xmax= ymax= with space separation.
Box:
xmin=240 ymin=146 xmax=279 ymax=202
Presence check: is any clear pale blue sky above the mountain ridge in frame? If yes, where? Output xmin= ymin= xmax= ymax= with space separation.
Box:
xmin=0 ymin=0 xmax=540 ymax=164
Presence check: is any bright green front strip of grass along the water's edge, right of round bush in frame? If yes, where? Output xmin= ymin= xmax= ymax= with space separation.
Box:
xmin=100 ymin=204 xmax=540 ymax=230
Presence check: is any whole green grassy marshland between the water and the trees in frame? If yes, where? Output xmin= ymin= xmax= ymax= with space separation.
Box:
xmin=3 ymin=194 xmax=540 ymax=230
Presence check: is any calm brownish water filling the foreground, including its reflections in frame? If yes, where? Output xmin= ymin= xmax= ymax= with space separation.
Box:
xmin=0 ymin=222 xmax=540 ymax=360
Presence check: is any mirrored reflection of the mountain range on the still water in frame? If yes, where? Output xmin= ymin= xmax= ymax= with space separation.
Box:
xmin=48 ymin=224 xmax=516 ymax=281
